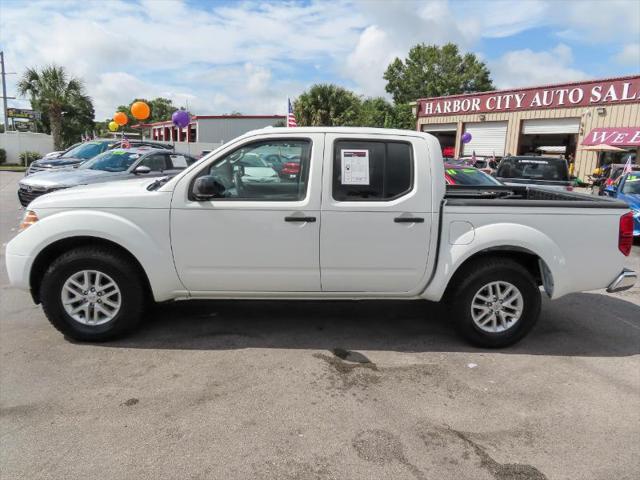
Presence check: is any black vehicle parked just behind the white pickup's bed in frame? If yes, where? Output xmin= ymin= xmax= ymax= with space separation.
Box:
xmin=495 ymin=156 xmax=573 ymax=191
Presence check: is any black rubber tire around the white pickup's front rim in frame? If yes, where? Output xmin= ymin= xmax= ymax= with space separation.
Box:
xmin=40 ymin=247 xmax=146 ymax=342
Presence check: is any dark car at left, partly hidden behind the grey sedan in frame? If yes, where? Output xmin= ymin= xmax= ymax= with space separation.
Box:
xmin=25 ymin=138 xmax=173 ymax=176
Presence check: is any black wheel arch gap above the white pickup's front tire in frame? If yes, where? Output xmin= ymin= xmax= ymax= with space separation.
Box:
xmin=29 ymin=235 xmax=153 ymax=304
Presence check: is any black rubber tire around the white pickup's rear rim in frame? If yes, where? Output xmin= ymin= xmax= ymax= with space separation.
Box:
xmin=446 ymin=257 xmax=541 ymax=348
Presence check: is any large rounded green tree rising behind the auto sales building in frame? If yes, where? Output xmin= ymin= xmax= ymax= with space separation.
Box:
xmin=384 ymin=43 xmax=493 ymax=104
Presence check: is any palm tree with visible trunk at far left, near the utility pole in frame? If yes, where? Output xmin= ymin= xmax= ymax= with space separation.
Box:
xmin=18 ymin=65 xmax=86 ymax=150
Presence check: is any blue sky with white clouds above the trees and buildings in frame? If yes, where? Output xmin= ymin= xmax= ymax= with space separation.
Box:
xmin=0 ymin=0 xmax=640 ymax=120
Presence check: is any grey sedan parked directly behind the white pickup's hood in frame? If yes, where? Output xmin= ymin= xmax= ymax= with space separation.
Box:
xmin=18 ymin=147 xmax=196 ymax=207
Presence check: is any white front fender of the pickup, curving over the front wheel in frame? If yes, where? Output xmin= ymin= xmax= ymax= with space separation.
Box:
xmin=7 ymin=209 xmax=184 ymax=301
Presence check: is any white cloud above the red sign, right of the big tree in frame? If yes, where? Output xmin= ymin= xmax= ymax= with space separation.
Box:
xmin=489 ymin=44 xmax=589 ymax=88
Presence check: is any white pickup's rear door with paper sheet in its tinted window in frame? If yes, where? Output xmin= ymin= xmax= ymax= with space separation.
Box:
xmin=320 ymin=134 xmax=436 ymax=294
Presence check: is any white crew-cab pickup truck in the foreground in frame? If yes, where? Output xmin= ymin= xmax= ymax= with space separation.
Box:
xmin=6 ymin=128 xmax=636 ymax=347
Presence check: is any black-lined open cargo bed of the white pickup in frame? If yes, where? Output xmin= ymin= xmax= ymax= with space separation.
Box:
xmin=445 ymin=185 xmax=629 ymax=209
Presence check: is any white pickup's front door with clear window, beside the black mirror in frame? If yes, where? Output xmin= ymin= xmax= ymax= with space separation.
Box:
xmin=171 ymin=133 xmax=324 ymax=296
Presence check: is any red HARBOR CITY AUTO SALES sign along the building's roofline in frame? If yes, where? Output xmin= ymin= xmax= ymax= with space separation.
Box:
xmin=418 ymin=76 xmax=640 ymax=117
